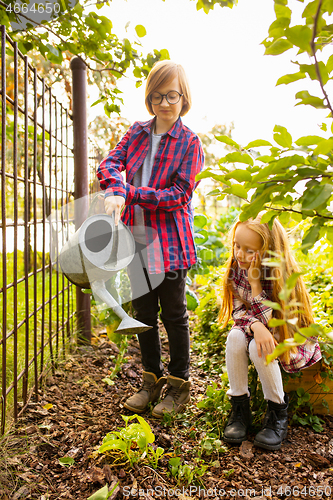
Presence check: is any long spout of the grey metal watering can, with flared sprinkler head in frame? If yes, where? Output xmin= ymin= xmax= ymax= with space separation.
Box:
xmin=91 ymin=280 xmax=152 ymax=335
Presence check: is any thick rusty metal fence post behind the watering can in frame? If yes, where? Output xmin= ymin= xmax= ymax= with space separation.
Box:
xmin=71 ymin=57 xmax=91 ymax=342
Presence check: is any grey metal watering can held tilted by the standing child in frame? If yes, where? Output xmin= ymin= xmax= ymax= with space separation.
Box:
xmin=58 ymin=197 xmax=151 ymax=335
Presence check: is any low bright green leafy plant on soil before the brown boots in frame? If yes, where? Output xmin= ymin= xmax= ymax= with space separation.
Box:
xmin=98 ymin=414 xmax=164 ymax=468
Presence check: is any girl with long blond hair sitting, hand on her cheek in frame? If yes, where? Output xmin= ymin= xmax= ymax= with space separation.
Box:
xmin=219 ymin=214 xmax=321 ymax=450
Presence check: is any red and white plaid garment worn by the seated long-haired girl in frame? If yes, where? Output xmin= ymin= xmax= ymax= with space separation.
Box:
xmin=232 ymin=266 xmax=321 ymax=373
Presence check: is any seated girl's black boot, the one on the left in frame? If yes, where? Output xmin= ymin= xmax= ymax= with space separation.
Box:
xmin=223 ymin=394 xmax=252 ymax=444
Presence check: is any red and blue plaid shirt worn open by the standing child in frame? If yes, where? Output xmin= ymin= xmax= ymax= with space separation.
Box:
xmin=97 ymin=118 xmax=204 ymax=273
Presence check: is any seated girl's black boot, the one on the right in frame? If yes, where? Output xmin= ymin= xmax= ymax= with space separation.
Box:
xmin=254 ymin=394 xmax=289 ymax=450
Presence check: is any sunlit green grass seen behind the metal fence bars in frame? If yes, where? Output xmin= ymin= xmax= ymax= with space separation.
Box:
xmin=0 ymin=251 xmax=75 ymax=432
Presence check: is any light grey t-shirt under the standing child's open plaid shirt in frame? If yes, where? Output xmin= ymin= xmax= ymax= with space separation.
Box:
xmin=133 ymin=131 xmax=164 ymax=245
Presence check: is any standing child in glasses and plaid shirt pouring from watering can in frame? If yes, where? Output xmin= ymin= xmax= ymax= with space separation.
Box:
xmin=97 ymin=61 xmax=204 ymax=417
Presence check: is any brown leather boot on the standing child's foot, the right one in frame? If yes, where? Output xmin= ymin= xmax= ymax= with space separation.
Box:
xmin=152 ymin=375 xmax=191 ymax=418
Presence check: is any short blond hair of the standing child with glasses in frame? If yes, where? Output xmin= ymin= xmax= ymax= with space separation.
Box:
xmin=145 ymin=60 xmax=192 ymax=116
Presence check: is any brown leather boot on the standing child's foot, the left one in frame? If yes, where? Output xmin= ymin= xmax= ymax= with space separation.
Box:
xmin=124 ymin=372 xmax=167 ymax=413
